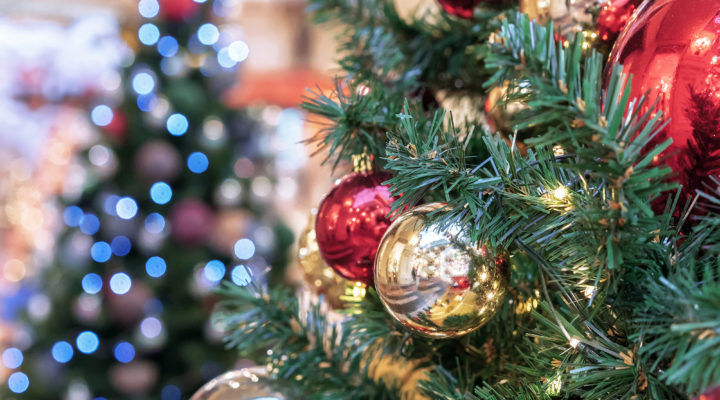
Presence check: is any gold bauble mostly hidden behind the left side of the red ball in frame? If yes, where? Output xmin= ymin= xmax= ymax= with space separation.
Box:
xmin=297 ymin=210 xmax=350 ymax=309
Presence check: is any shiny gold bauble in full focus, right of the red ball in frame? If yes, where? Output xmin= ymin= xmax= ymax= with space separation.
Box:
xmin=375 ymin=203 xmax=510 ymax=338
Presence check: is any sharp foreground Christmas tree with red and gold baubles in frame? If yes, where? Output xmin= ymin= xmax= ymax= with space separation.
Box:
xmin=210 ymin=0 xmax=720 ymax=399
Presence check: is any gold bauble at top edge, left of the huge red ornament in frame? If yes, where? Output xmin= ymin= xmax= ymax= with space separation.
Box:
xmin=520 ymin=0 xmax=599 ymax=39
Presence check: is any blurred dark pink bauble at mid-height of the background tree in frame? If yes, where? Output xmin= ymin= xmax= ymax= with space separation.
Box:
xmin=170 ymin=198 xmax=215 ymax=246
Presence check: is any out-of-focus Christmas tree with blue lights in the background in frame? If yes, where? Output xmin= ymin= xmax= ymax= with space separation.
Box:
xmin=3 ymin=0 xmax=292 ymax=400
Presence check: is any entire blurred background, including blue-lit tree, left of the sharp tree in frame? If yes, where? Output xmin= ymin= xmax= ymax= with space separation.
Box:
xmin=0 ymin=0 xmax=344 ymax=400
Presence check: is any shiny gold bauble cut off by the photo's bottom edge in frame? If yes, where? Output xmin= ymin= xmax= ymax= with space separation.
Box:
xmin=190 ymin=367 xmax=285 ymax=400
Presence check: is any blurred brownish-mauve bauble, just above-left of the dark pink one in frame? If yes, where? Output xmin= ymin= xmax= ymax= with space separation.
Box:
xmin=135 ymin=140 xmax=182 ymax=182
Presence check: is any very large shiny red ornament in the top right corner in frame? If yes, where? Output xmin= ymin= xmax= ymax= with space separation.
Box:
xmin=606 ymin=0 xmax=720 ymax=216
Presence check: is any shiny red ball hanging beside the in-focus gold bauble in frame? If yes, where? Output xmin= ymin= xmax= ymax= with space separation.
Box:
xmin=315 ymin=172 xmax=394 ymax=285
